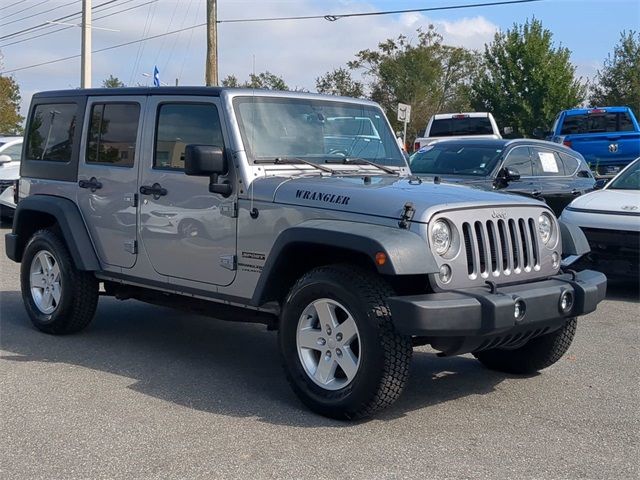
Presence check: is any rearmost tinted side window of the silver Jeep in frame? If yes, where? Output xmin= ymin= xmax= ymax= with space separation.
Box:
xmin=27 ymin=103 xmax=78 ymax=162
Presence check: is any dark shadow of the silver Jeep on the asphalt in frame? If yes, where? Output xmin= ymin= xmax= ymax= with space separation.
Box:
xmin=0 ymin=291 xmax=509 ymax=428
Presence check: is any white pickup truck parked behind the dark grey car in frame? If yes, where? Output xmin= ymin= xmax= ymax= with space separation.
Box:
xmin=414 ymin=112 xmax=502 ymax=151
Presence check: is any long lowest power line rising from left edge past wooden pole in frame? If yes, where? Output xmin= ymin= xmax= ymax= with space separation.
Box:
xmin=0 ymin=0 xmax=543 ymax=74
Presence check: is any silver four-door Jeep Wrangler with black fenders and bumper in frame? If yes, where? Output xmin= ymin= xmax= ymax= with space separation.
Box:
xmin=6 ymin=87 xmax=606 ymax=419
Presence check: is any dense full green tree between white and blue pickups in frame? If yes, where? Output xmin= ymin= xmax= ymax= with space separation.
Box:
xmin=471 ymin=18 xmax=586 ymax=135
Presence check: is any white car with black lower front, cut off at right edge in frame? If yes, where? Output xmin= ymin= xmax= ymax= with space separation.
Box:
xmin=561 ymin=158 xmax=640 ymax=280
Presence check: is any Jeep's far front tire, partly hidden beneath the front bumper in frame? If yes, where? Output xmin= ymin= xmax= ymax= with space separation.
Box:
xmin=473 ymin=317 xmax=577 ymax=374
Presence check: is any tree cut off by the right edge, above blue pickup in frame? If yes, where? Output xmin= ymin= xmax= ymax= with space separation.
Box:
xmin=590 ymin=30 xmax=640 ymax=115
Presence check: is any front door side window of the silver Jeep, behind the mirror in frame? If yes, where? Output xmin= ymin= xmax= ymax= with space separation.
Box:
xmin=153 ymin=103 xmax=224 ymax=170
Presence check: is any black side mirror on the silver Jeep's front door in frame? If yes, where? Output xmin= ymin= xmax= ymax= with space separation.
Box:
xmin=184 ymin=145 xmax=232 ymax=197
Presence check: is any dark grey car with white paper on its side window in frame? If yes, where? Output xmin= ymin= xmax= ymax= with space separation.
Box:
xmin=409 ymin=138 xmax=595 ymax=215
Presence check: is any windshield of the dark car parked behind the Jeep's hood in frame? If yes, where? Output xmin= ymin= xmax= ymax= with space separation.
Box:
xmin=409 ymin=141 xmax=502 ymax=177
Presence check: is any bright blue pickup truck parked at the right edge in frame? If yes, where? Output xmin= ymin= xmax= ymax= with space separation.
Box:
xmin=535 ymin=107 xmax=640 ymax=177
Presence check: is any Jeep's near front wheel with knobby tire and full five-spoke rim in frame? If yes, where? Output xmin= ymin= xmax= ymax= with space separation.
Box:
xmin=278 ymin=265 xmax=412 ymax=420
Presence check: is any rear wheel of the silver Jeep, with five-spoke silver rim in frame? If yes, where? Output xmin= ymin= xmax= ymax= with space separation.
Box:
xmin=20 ymin=230 xmax=98 ymax=334
